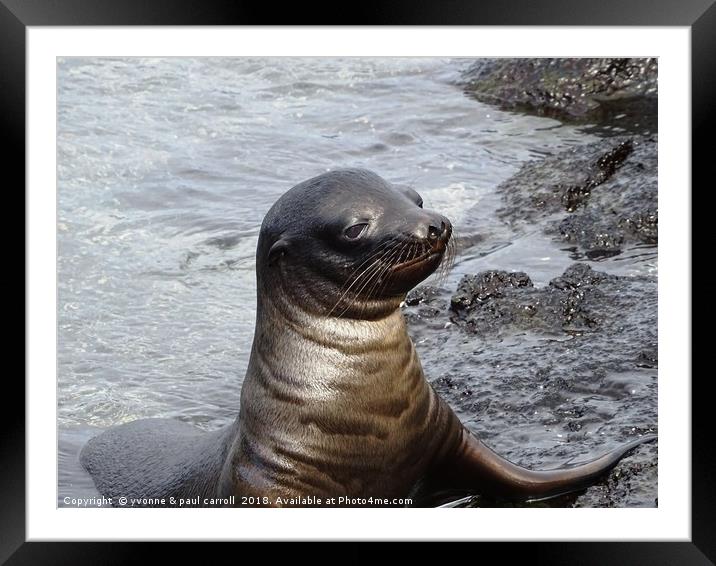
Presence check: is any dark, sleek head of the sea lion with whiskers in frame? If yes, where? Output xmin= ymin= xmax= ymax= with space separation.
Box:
xmin=256 ymin=169 xmax=452 ymax=318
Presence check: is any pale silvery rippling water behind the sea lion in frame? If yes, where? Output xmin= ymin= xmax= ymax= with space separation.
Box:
xmin=57 ymin=58 xmax=656 ymax=506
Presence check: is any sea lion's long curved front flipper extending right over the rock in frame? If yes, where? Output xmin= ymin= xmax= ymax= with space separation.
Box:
xmin=434 ymin=431 xmax=657 ymax=501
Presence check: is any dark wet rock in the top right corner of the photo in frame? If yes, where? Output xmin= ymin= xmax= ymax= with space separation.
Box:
xmin=460 ymin=58 xmax=658 ymax=133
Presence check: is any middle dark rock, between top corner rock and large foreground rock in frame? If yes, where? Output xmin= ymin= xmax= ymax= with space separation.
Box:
xmin=497 ymin=136 xmax=658 ymax=258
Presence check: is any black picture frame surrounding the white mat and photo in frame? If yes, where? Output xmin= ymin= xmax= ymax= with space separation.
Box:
xmin=7 ymin=0 xmax=704 ymax=566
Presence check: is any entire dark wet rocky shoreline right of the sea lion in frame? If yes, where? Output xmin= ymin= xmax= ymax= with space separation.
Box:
xmin=403 ymin=59 xmax=658 ymax=507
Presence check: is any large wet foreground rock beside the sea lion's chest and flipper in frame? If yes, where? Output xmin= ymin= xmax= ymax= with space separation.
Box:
xmin=404 ymin=263 xmax=658 ymax=507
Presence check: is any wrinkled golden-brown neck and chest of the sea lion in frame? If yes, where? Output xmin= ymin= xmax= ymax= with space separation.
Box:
xmin=222 ymin=311 xmax=454 ymax=501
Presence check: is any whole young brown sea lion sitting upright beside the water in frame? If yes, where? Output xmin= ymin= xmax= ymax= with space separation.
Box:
xmin=81 ymin=169 xmax=655 ymax=506
